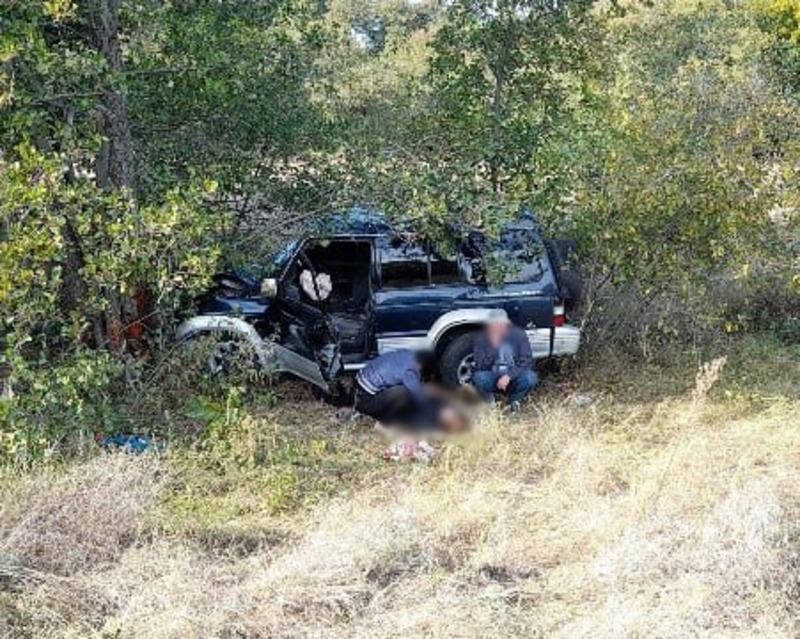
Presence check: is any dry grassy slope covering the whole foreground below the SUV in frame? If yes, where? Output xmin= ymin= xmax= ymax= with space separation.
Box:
xmin=0 ymin=332 xmax=800 ymax=637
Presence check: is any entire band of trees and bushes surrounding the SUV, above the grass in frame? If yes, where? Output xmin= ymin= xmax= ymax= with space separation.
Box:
xmin=0 ymin=0 xmax=800 ymax=464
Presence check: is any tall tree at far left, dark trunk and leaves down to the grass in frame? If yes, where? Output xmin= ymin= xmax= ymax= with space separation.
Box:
xmin=0 ymin=0 xmax=225 ymax=464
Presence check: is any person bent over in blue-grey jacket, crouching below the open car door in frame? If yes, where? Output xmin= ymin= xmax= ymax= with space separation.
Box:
xmin=355 ymin=350 xmax=466 ymax=432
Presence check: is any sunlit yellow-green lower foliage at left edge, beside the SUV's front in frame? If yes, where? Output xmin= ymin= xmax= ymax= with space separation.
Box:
xmin=0 ymin=145 xmax=219 ymax=470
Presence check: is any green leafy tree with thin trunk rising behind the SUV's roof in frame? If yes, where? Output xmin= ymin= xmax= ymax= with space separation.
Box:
xmin=324 ymin=0 xmax=596 ymax=233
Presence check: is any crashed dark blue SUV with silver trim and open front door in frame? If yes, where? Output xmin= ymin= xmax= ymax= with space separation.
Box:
xmin=178 ymin=211 xmax=580 ymax=390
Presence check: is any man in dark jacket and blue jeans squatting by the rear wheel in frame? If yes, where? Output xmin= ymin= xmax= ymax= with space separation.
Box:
xmin=472 ymin=309 xmax=539 ymax=411
